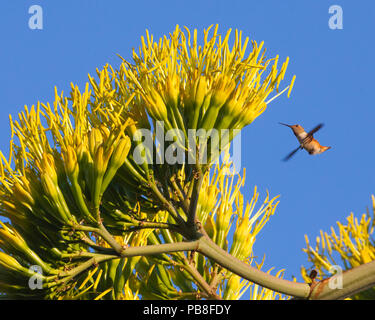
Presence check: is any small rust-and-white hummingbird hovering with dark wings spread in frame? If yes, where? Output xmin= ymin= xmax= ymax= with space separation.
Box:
xmin=279 ymin=122 xmax=331 ymax=161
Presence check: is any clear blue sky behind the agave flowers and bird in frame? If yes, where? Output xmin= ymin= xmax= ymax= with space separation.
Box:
xmin=0 ymin=0 xmax=375 ymax=288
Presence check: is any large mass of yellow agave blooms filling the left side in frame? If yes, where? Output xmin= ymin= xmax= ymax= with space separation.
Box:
xmin=0 ymin=26 xmax=294 ymax=299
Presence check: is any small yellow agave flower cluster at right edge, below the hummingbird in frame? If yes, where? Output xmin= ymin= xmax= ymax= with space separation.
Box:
xmin=301 ymin=196 xmax=375 ymax=300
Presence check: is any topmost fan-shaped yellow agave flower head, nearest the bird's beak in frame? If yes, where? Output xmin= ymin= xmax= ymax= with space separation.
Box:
xmin=118 ymin=25 xmax=295 ymax=166
